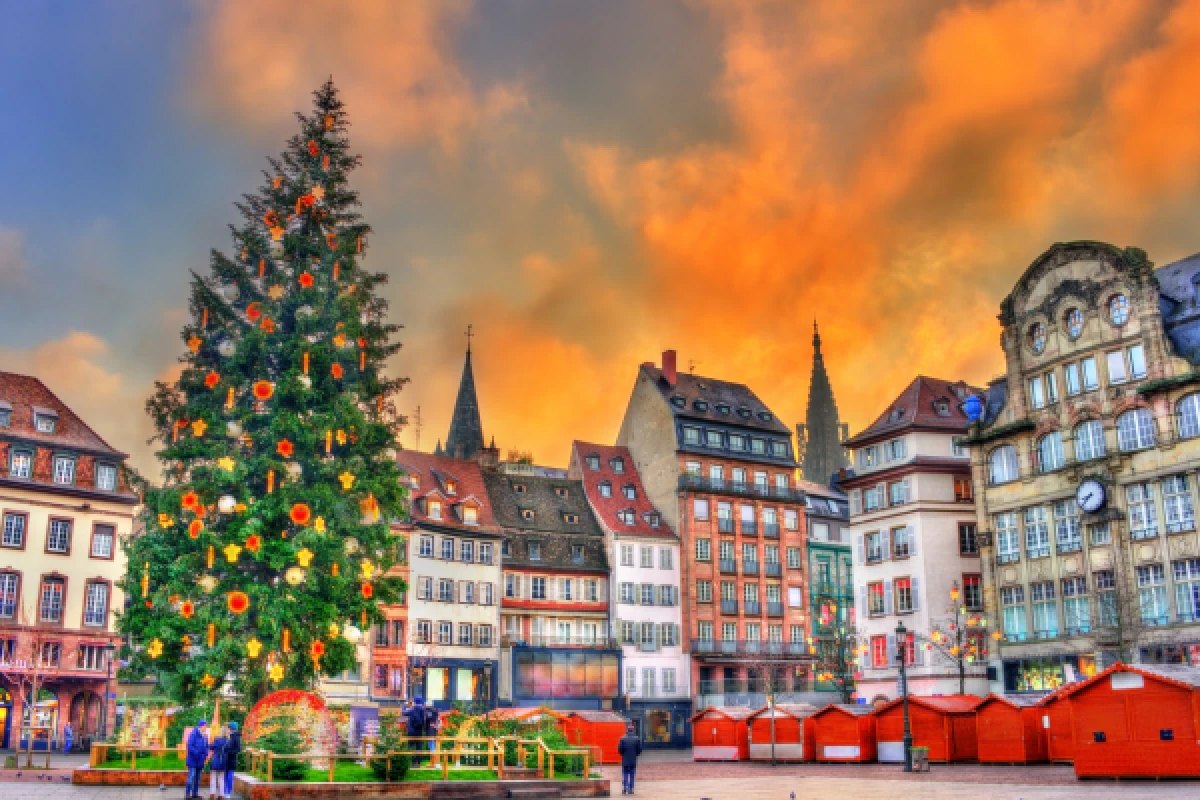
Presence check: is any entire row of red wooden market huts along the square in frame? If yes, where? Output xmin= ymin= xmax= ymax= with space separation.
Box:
xmin=691 ymin=663 xmax=1200 ymax=777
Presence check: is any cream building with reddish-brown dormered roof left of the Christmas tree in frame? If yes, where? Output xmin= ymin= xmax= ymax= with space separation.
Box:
xmin=0 ymin=372 xmax=138 ymax=748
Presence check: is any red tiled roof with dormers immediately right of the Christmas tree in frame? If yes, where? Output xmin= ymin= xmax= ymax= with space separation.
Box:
xmin=396 ymin=450 xmax=499 ymax=534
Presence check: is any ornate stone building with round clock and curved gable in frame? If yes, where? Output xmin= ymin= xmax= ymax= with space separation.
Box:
xmin=970 ymin=242 xmax=1200 ymax=692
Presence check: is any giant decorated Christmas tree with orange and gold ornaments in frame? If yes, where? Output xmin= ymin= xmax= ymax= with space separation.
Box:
xmin=119 ymin=82 xmax=404 ymax=702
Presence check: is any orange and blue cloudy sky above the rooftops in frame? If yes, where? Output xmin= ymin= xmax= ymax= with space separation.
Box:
xmin=0 ymin=0 xmax=1200 ymax=470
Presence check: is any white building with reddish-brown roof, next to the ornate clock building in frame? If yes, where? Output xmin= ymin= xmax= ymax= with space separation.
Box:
xmin=841 ymin=377 xmax=990 ymax=702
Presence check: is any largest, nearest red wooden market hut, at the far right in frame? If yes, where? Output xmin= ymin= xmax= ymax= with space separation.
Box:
xmin=1067 ymin=663 xmax=1200 ymax=778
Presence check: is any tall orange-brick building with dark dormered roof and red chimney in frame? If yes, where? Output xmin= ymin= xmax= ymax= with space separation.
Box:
xmin=617 ymin=350 xmax=811 ymax=708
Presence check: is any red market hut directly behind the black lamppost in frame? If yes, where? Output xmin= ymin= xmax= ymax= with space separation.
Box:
xmin=875 ymin=694 xmax=980 ymax=763
